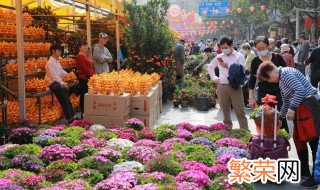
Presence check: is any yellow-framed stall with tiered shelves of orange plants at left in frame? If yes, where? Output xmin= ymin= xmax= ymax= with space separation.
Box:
xmin=0 ymin=0 xmax=123 ymax=123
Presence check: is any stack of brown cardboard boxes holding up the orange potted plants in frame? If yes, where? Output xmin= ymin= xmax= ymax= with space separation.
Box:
xmin=83 ymin=81 xmax=162 ymax=128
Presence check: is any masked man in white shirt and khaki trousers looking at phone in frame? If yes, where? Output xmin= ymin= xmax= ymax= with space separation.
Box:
xmin=208 ymin=37 xmax=248 ymax=129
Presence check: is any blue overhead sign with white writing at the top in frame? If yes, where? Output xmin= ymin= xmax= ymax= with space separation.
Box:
xmin=199 ymin=0 xmax=230 ymax=16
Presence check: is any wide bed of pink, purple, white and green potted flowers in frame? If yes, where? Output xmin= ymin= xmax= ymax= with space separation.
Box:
xmin=0 ymin=119 xmax=254 ymax=190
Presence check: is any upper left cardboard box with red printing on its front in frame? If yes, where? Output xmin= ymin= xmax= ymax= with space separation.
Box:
xmin=84 ymin=93 xmax=131 ymax=117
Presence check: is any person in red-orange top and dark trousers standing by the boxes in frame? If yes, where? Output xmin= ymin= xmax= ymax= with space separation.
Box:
xmin=76 ymin=42 xmax=94 ymax=116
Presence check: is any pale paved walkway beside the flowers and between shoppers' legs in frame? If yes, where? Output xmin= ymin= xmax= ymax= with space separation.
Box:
xmin=156 ymin=102 xmax=312 ymax=190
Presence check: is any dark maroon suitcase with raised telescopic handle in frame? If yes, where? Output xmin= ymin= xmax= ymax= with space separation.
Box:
xmin=248 ymin=106 xmax=291 ymax=160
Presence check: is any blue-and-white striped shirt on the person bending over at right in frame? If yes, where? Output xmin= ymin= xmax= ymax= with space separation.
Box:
xmin=279 ymin=67 xmax=320 ymax=119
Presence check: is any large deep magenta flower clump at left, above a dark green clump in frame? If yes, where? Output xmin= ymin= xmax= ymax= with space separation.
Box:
xmin=39 ymin=144 xmax=76 ymax=162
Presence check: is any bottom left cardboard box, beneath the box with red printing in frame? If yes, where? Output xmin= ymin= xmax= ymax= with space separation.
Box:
xmin=83 ymin=115 xmax=130 ymax=127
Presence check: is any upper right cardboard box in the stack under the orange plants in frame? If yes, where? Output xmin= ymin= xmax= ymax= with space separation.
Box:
xmin=131 ymin=91 xmax=157 ymax=116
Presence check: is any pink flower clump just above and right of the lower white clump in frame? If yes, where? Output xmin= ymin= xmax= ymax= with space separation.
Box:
xmin=128 ymin=146 xmax=159 ymax=164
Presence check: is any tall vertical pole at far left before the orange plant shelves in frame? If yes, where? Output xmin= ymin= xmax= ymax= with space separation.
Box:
xmin=16 ymin=0 xmax=26 ymax=119
